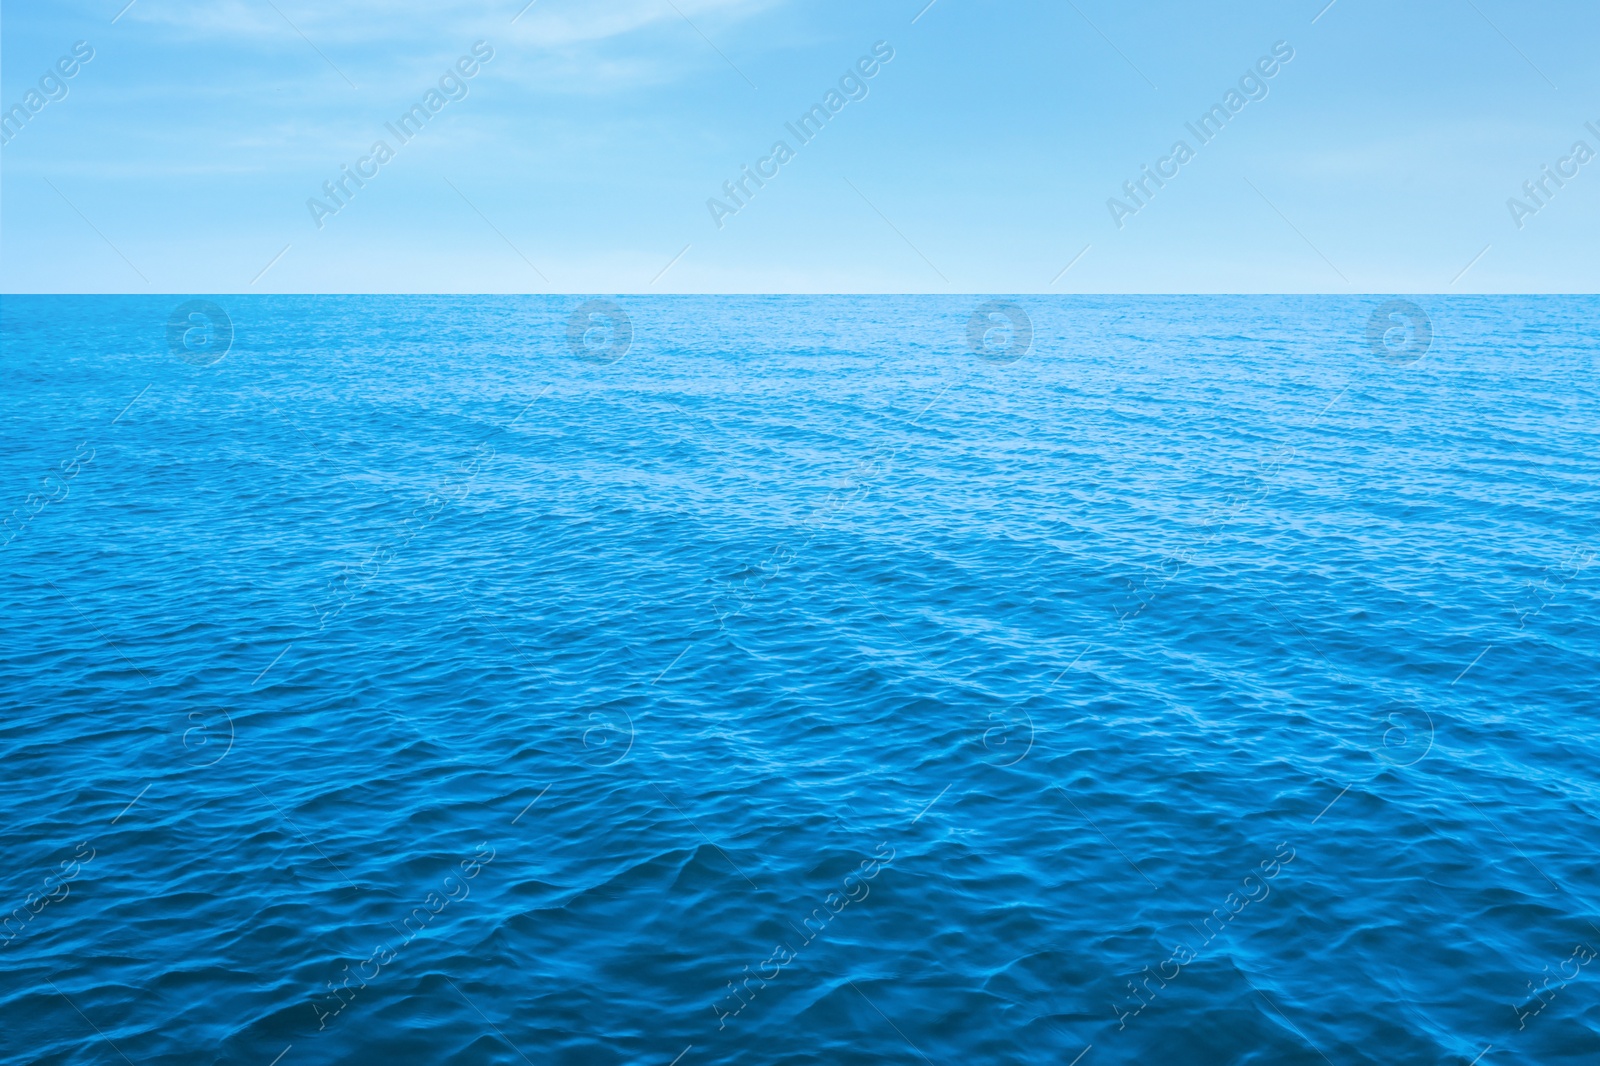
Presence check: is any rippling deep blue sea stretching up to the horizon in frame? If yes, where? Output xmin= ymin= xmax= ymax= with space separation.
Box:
xmin=0 ymin=298 xmax=1600 ymax=1066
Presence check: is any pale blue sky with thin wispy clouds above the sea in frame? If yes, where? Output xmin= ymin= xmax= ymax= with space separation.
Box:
xmin=0 ymin=0 xmax=1600 ymax=293
